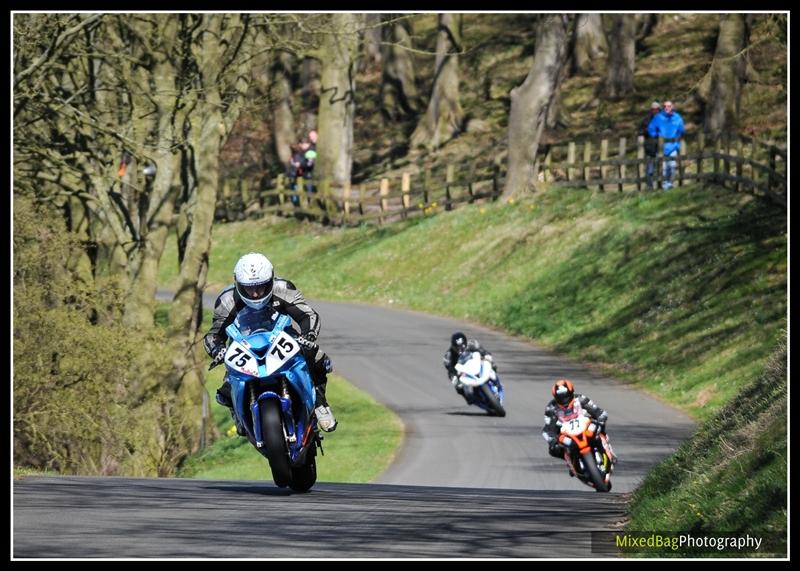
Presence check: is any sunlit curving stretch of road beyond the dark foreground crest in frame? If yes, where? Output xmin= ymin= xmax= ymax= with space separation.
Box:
xmin=314 ymin=302 xmax=693 ymax=492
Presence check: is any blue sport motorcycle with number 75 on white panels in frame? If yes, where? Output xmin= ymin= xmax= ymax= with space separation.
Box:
xmin=212 ymin=307 xmax=322 ymax=492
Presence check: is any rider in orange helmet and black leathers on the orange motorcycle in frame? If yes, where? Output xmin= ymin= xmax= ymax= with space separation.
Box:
xmin=542 ymin=379 xmax=616 ymax=476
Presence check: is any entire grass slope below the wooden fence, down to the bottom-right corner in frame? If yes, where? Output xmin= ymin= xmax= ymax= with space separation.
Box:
xmin=162 ymin=185 xmax=788 ymax=537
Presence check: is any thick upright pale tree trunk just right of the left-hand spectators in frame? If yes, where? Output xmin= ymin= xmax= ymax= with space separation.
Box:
xmin=314 ymin=13 xmax=361 ymax=184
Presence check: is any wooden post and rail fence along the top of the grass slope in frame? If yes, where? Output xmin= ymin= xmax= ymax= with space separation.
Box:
xmin=216 ymin=133 xmax=788 ymax=226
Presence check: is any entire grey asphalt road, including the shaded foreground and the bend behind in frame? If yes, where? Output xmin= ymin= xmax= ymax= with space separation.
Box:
xmin=13 ymin=299 xmax=693 ymax=558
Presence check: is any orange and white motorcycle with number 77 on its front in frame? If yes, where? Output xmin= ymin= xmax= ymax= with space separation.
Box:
xmin=558 ymin=415 xmax=617 ymax=492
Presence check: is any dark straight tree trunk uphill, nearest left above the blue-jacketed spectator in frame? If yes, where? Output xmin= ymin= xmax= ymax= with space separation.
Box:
xmin=604 ymin=14 xmax=636 ymax=101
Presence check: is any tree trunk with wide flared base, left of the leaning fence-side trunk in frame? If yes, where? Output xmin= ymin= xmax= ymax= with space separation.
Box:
xmin=411 ymin=14 xmax=464 ymax=149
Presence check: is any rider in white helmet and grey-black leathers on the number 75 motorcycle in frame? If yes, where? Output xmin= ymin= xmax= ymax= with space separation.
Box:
xmin=203 ymin=252 xmax=336 ymax=432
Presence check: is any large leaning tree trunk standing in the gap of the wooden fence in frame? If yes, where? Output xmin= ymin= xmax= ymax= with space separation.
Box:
xmin=503 ymin=15 xmax=569 ymax=199
